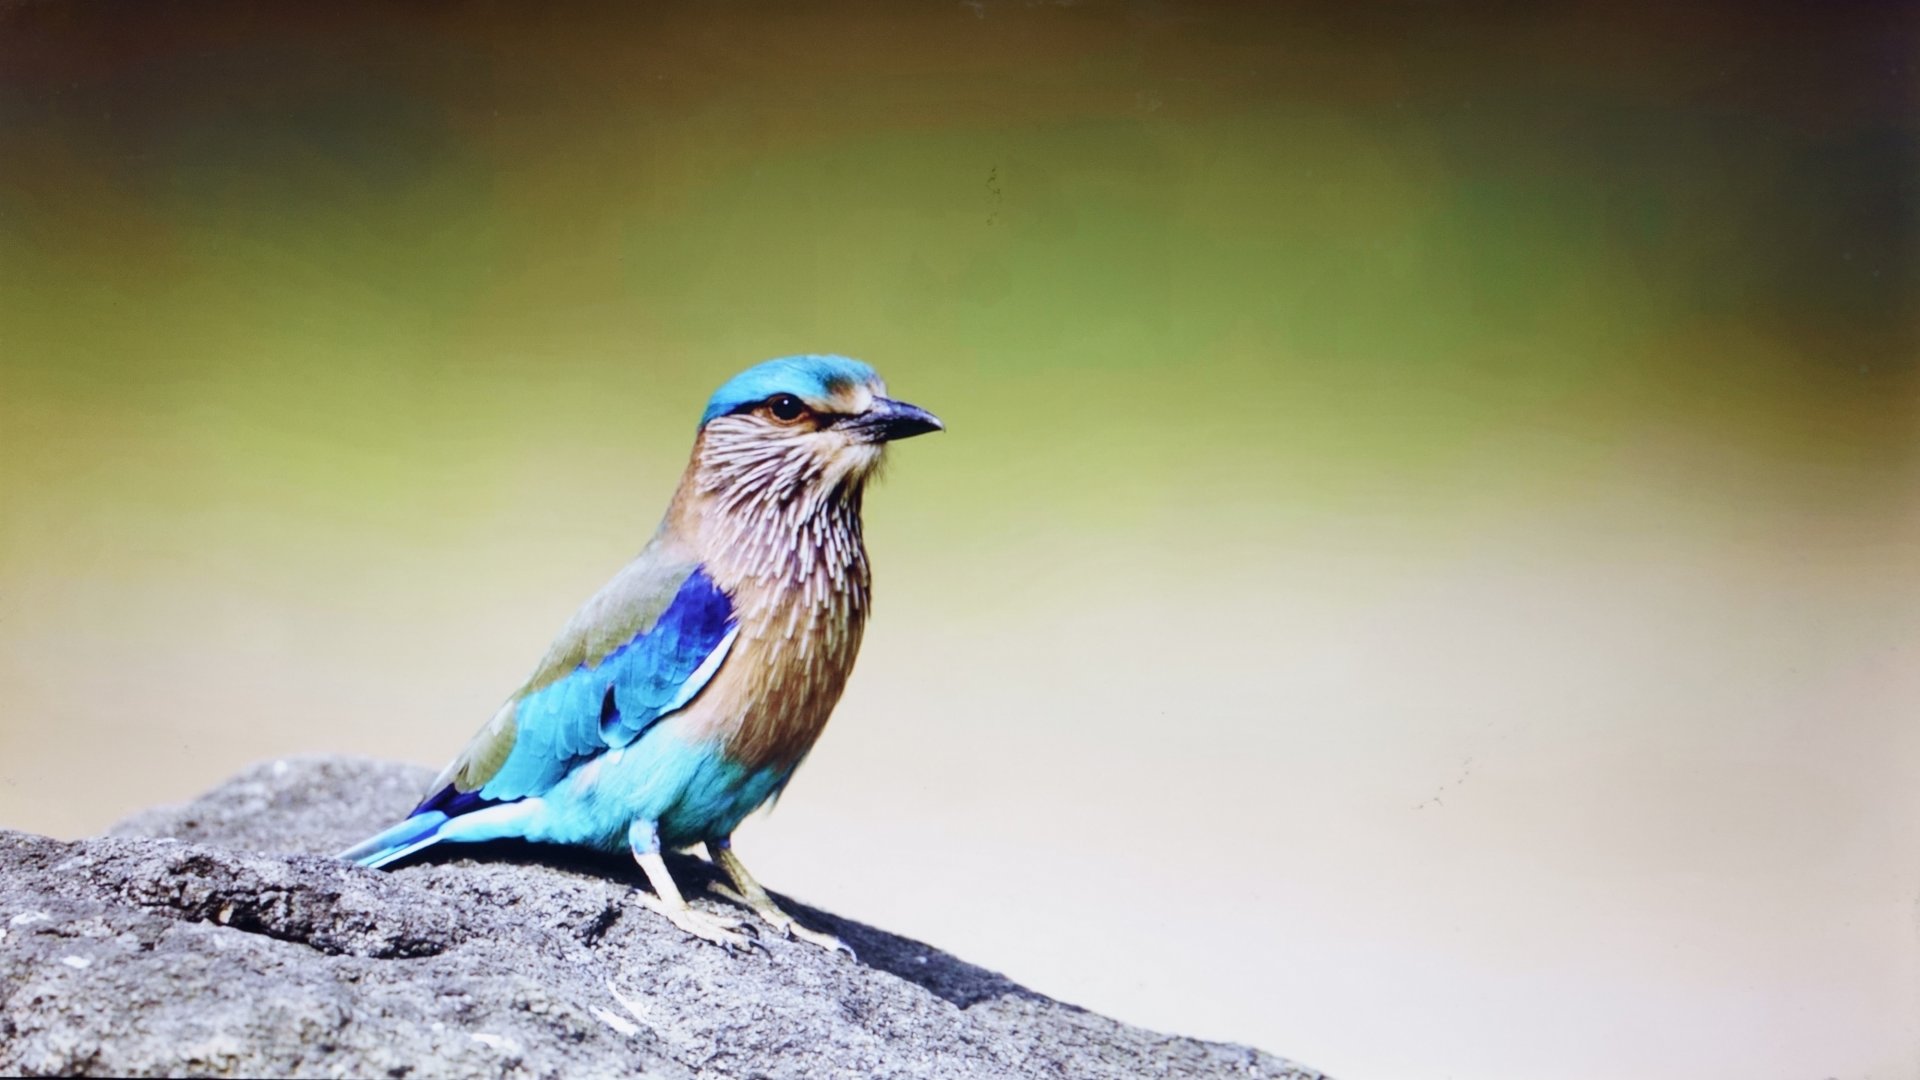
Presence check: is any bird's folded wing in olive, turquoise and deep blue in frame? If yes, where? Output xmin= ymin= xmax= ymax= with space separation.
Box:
xmin=420 ymin=548 xmax=735 ymax=813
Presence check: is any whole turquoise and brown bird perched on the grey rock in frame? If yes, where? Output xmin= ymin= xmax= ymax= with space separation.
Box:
xmin=338 ymin=354 xmax=945 ymax=955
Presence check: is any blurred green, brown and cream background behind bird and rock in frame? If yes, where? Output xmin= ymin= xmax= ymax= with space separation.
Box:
xmin=0 ymin=0 xmax=1920 ymax=1078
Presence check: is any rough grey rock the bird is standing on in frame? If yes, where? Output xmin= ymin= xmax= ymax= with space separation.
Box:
xmin=0 ymin=759 xmax=1319 ymax=1080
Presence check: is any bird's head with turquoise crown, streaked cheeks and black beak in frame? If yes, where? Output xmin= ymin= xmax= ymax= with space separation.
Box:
xmin=695 ymin=356 xmax=945 ymax=498
